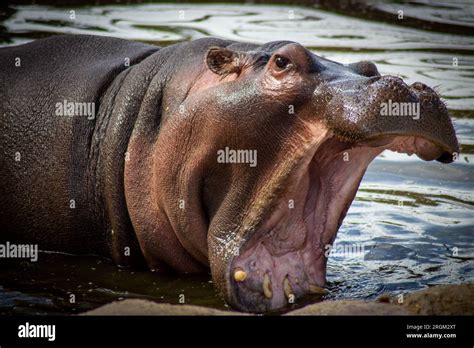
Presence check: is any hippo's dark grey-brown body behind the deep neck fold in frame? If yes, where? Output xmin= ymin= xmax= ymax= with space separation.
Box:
xmin=0 ymin=35 xmax=159 ymax=252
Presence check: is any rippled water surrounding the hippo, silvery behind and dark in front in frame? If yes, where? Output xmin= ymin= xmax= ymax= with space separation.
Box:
xmin=0 ymin=1 xmax=474 ymax=314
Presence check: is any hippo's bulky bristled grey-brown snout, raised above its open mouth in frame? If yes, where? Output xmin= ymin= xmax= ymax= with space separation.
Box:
xmin=325 ymin=76 xmax=459 ymax=163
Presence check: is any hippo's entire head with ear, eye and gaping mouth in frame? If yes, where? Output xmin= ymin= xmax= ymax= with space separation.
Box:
xmin=128 ymin=42 xmax=458 ymax=312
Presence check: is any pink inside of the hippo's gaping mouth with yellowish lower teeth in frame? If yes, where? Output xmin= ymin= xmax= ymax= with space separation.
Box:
xmin=227 ymin=133 xmax=452 ymax=312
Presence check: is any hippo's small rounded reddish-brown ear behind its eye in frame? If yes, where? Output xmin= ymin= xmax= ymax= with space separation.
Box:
xmin=206 ymin=47 xmax=242 ymax=77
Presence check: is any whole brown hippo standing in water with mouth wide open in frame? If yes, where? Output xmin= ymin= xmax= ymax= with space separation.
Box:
xmin=0 ymin=35 xmax=459 ymax=313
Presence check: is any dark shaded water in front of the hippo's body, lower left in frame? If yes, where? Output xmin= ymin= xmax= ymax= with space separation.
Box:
xmin=0 ymin=253 xmax=228 ymax=314
